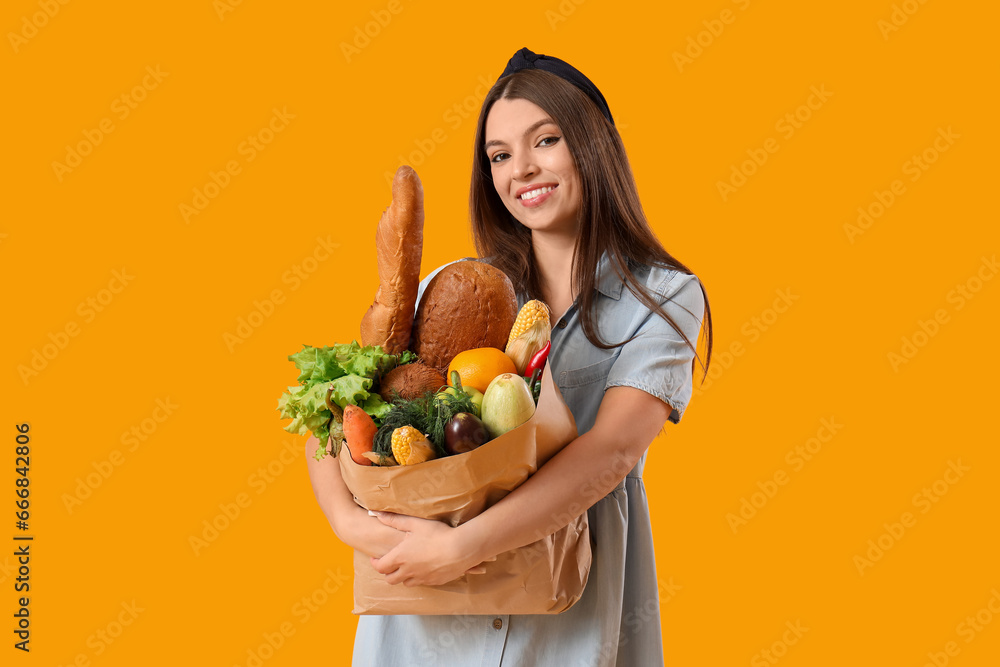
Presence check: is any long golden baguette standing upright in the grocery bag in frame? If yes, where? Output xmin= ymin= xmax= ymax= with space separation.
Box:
xmin=361 ymin=165 xmax=424 ymax=354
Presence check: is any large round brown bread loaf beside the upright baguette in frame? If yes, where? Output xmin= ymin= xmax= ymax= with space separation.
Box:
xmin=413 ymin=261 xmax=517 ymax=374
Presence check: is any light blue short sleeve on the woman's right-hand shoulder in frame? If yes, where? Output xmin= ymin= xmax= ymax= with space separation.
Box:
xmin=605 ymin=272 xmax=705 ymax=424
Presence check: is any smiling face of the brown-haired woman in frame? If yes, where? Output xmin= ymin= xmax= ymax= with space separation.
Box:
xmin=485 ymin=98 xmax=581 ymax=237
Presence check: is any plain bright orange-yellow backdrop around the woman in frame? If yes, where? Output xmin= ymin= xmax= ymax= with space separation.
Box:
xmin=0 ymin=0 xmax=1000 ymax=667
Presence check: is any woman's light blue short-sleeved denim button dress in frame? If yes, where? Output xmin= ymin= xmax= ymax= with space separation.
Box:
xmin=353 ymin=253 xmax=704 ymax=667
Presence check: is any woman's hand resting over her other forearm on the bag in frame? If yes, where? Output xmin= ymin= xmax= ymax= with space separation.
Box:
xmin=372 ymin=512 xmax=496 ymax=586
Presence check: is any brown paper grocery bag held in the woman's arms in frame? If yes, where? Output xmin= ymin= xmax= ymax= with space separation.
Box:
xmin=337 ymin=366 xmax=591 ymax=614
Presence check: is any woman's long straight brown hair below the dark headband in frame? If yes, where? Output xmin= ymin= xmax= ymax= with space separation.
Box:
xmin=469 ymin=69 xmax=712 ymax=381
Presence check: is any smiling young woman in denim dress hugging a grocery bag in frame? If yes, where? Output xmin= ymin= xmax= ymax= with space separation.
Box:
xmin=306 ymin=49 xmax=712 ymax=667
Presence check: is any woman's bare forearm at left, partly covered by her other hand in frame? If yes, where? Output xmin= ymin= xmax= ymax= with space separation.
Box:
xmin=306 ymin=436 xmax=404 ymax=557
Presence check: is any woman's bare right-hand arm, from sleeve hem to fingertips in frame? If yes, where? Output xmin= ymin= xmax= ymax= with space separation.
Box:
xmin=372 ymin=387 xmax=671 ymax=586
